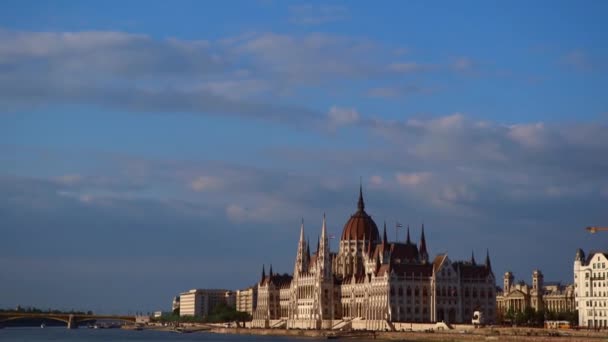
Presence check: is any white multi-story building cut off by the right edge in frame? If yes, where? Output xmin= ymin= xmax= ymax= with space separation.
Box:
xmin=574 ymin=248 xmax=608 ymax=328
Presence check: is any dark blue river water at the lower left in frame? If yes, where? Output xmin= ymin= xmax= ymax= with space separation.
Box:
xmin=0 ymin=327 xmax=363 ymax=342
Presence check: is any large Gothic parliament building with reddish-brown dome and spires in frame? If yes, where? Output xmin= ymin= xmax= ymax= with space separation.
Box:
xmin=252 ymin=189 xmax=496 ymax=330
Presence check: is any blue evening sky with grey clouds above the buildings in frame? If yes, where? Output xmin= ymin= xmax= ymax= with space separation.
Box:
xmin=0 ymin=1 xmax=608 ymax=312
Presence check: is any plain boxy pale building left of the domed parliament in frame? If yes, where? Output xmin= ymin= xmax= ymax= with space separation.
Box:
xmin=179 ymin=289 xmax=235 ymax=316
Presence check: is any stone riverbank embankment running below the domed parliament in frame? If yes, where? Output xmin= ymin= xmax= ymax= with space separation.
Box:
xmin=207 ymin=328 xmax=608 ymax=342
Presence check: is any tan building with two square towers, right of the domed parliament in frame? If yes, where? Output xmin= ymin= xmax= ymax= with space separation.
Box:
xmin=496 ymin=270 xmax=576 ymax=317
